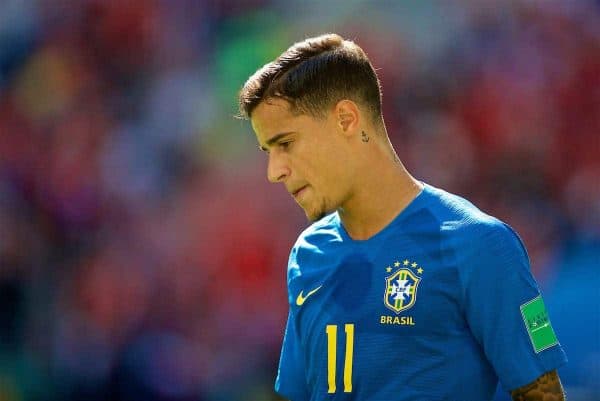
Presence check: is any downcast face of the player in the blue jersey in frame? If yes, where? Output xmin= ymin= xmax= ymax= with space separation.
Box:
xmin=251 ymin=99 xmax=352 ymax=221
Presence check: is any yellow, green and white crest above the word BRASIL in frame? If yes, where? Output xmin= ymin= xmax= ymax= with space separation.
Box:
xmin=383 ymin=268 xmax=421 ymax=313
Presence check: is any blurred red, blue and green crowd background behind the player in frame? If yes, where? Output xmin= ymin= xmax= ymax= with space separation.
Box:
xmin=0 ymin=0 xmax=600 ymax=401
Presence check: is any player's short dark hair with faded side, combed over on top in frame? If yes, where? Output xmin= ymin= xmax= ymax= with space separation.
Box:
xmin=239 ymin=33 xmax=381 ymax=119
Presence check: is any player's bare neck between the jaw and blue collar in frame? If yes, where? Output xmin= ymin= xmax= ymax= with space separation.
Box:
xmin=338 ymin=138 xmax=423 ymax=240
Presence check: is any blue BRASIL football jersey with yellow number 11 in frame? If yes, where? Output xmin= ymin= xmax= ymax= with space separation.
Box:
xmin=275 ymin=184 xmax=566 ymax=401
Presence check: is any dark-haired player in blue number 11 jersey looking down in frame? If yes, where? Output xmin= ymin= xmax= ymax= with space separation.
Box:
xmin=239 ymin=34 xmax=566 ymax=401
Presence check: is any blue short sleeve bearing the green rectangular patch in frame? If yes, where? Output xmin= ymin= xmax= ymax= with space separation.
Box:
xmin=463 ymin=222 xmax=566 ymax=391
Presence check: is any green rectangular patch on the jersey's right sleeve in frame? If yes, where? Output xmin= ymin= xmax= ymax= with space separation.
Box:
xmin=521 ymin=295 xmax=558 ymax=354
